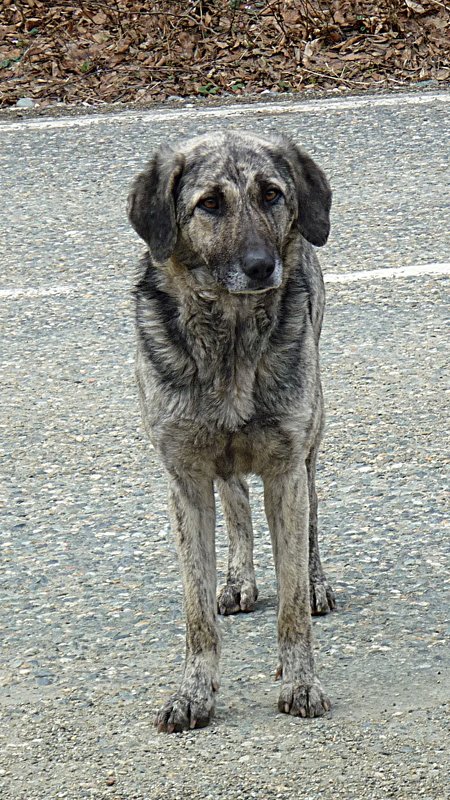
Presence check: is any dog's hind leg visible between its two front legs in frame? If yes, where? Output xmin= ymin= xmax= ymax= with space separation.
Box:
xmin=217 ymin=477 xmax=258 ymax=614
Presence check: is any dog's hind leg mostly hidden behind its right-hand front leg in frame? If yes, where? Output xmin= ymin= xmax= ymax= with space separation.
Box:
xmin=306 ymin=444 xmax=336 ymax=616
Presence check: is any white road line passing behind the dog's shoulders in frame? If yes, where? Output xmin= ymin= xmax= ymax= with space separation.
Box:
xmin=0 ymin=261 xmax=450 ymax=300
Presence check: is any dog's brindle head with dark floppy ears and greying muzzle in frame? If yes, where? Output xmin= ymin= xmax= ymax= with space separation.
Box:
xmin=128 ymin=132 xmax=331 ymax=294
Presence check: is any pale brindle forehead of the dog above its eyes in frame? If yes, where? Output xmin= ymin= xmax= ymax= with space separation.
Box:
xmin=182 ymin=133 xmax=277 ymax=182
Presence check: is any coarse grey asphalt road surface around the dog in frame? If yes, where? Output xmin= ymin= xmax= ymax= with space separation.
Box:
xmin=0 ymin=93 xmax=450 ymax=800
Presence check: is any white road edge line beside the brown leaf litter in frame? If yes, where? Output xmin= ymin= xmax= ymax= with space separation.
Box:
xmin=0 ymin=92 xmax=450 ymax=136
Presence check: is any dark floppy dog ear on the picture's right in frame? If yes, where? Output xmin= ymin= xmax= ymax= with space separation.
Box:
xmin=284 ymin=138 xmax=331 ymax=247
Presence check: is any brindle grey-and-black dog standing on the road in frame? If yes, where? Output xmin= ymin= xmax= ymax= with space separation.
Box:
xmin=128 ymin=131 xmax=335 ymax=733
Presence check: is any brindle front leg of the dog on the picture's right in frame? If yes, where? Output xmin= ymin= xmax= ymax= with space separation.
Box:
xmin=264 ymin=464 xmax=330 ymax=717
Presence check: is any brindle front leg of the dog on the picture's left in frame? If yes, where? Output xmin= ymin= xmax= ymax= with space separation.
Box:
xmin=156 ymin=477 xmax=220 ymax=733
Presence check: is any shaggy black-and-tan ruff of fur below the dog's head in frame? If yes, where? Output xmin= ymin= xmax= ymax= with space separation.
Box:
xmin=136 ymin=255 xmax=307 ymax=431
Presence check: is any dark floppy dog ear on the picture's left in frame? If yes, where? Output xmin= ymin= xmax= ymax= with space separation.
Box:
xmin=127 ymin=147 xmax=184 ymax=262
